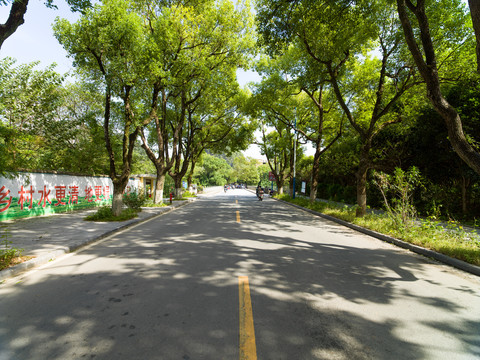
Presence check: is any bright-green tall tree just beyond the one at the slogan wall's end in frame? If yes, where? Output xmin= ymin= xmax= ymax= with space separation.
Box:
xmin=137 ymin=0 xmax=253 ymax=201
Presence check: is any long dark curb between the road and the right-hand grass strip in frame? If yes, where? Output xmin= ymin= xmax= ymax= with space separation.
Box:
xmin=275 ymin=199 xmax=480 ymax=276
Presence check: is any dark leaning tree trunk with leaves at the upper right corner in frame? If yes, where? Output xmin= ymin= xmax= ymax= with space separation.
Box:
xmin=397 ymin=0 xmax=480 ymax=174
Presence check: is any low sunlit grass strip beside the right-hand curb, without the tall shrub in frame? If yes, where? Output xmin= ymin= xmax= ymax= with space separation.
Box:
xmin=276 ymin=195 xmax=480 ymax=266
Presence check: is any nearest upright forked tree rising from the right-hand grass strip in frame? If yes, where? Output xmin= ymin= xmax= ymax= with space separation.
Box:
xmin=259 ymin=0 xmax=417 ymax=216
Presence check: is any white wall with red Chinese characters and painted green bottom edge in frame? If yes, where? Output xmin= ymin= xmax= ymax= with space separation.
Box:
xmin=0 ymin=173 xmax=138 ymax=221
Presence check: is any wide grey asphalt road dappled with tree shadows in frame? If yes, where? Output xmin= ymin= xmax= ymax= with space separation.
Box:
xmin=0 ymin=190 xmax=480 ymax=360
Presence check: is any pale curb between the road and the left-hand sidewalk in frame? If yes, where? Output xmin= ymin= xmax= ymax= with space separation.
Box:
xmin=0 ymin=200 xmax=193 ymax=284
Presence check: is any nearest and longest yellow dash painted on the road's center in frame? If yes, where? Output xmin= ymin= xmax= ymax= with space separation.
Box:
xmin=238 ymin=276 xmax=257 ymax=360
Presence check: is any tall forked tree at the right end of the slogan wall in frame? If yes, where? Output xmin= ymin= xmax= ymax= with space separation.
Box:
xmin=54 ymin=0 xmax=159 ymax=215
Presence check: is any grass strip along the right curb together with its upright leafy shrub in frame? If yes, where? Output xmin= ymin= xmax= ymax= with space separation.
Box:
xmin=279 ymin=167 xmax=480 ymax=265
